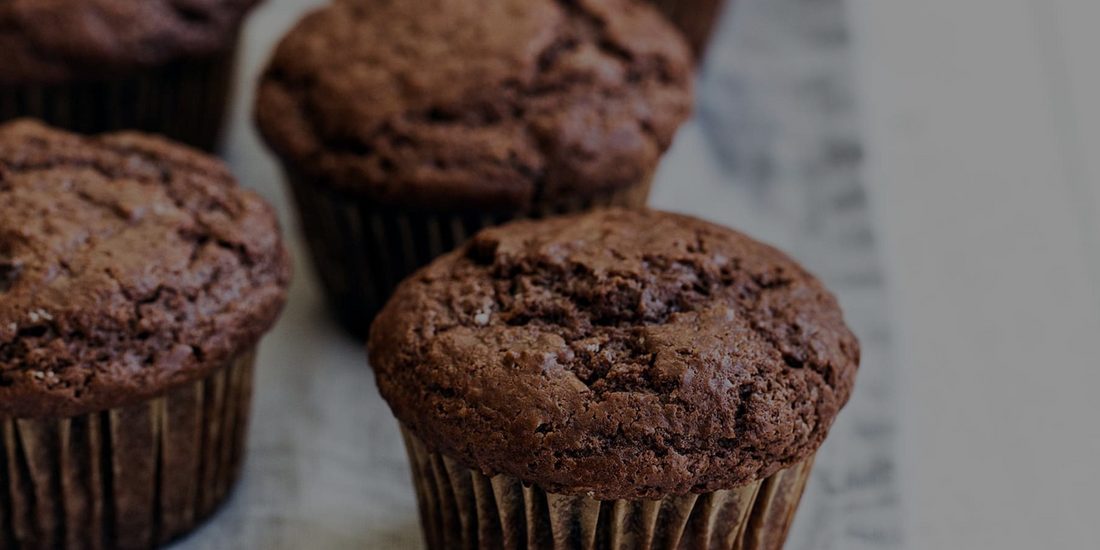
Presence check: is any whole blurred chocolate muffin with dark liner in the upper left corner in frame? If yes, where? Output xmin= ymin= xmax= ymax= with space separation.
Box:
xmin=0 ymin=0 xmax=260 ymax=150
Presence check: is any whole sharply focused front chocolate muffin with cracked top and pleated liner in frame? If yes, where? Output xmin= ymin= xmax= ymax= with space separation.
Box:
xmin=369 ymin=210 xmax=859 ymax=550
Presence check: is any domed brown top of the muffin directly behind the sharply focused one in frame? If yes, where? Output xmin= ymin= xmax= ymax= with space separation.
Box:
xmin=256 ymin=0 xmax=692 ymax=210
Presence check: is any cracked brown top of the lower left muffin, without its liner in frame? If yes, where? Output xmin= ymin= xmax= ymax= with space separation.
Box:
xmin=0 ymin=121 xmax=289 ymax=418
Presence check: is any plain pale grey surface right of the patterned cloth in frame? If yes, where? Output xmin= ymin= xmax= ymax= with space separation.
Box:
xmin=849 ymin=0 xmax=1100 ymax=550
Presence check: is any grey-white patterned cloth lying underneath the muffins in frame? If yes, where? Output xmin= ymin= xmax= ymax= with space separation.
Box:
xmin=171 ymin=0 xmax=902 ymax=550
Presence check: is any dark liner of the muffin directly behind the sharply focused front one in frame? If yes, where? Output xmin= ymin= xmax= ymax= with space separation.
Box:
xmin=287 ymin=171 xmax=652 ymax=338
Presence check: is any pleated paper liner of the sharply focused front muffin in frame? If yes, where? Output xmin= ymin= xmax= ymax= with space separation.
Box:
xmin=403 ymin=429 xmax=813 ymax=550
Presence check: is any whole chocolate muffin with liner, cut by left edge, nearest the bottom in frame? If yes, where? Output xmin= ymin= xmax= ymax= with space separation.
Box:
xmin=0 ymin=121 xmax=289 ymax=550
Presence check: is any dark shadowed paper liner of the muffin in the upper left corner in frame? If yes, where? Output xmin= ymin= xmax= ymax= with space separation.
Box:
xmin=0 ymin=44 xmax=237 ymax=151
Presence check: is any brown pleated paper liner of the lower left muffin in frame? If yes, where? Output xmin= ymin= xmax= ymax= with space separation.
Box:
xmin=0 ymin=352 xmax=255 ymax=550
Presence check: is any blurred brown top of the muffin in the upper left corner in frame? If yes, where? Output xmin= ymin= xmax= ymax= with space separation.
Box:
xmin=0 ymin=0 xmax=260 ymax=83
